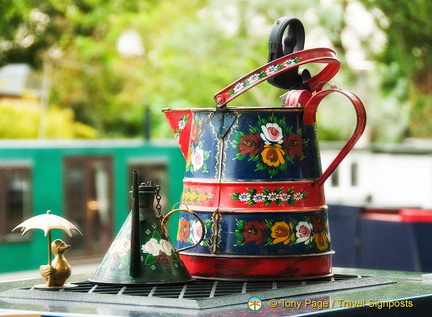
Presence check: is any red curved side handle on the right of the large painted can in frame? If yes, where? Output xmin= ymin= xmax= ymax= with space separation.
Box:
xmin=303 ymin=89 xmax=366 ymax=186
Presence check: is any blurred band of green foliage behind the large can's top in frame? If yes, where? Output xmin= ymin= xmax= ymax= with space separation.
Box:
xmin=0 ymin=0 xmax=432 ymax=140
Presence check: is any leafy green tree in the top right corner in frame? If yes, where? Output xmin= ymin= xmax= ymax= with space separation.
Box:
xmin=361 ymin=0 xmax=432 ymax=138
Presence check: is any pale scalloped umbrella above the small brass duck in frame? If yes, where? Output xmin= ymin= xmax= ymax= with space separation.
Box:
xmin=12 ymin=210 xmax=83 ymax=266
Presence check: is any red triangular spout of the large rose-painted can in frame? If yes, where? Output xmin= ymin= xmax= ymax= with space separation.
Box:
xmin=162 ymin=109 xmax=192 ymax=159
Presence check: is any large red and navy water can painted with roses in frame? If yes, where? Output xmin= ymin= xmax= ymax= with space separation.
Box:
xmin=163 ymin=18 xmax=366 ymax=280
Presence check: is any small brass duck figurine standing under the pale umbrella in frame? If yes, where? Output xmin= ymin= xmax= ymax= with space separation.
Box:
xmin=39 ymin=239 xmax=71 ymax=287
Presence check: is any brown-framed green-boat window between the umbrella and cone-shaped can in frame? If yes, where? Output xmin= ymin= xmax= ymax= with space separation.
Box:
xmin=64 ymin=156 xmax=113 ymax=257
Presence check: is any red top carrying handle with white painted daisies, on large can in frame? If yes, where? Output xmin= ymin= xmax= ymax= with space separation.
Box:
xmin=214 ymin=48 xmax=340 ymax=107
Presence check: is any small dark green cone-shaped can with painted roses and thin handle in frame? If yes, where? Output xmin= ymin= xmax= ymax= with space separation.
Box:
xmin=90 ymin=171 xmax=204 ymax=284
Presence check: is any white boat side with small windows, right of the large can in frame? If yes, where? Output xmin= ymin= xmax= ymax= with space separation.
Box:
xmin=321 ymin=150 xmax=432 ymax=208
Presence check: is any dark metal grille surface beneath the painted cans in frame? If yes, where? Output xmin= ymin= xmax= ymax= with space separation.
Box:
xmin=0 ymin=274 xmax=394 ymax=315
